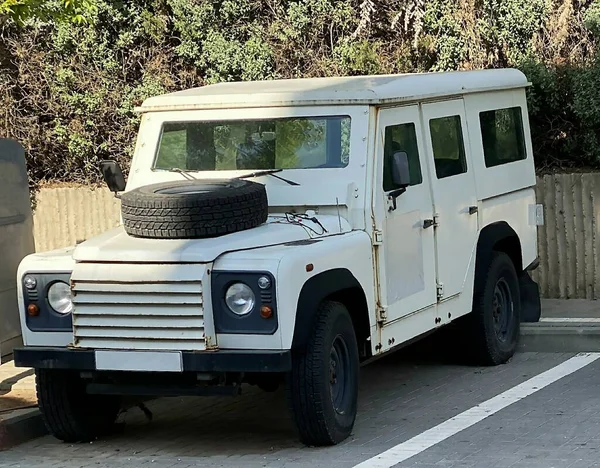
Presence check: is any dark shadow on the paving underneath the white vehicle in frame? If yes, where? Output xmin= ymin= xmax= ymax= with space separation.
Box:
xmin=85 ymin=330 xmax=477 ymax=457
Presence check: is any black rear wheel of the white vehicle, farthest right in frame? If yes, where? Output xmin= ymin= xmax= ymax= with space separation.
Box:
xmin=469 ymin=252 xmax=521 ymax=365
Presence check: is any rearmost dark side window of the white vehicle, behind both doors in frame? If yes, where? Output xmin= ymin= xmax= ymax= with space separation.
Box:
xmin=479 ymin=107 xmax=527 ymax=167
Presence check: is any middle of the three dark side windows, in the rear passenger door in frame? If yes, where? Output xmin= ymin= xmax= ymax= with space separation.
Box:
xmin=429 ymin=115 xmax=467 ymax=179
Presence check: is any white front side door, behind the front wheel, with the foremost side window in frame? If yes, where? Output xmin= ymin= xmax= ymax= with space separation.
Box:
xmin=374 ymin=106 xmax=436 ymax=322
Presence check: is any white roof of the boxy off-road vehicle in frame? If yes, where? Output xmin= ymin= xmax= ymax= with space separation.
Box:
xmin=137 ymin=68 xmax=529 ymax=112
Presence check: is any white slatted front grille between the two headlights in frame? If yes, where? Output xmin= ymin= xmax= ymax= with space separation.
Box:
xmin=72 ymin=265 xmax=206 ymax=350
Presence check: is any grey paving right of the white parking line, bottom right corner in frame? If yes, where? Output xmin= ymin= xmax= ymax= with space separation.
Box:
xmin=397 ymin=361 xmax=600 ymax=468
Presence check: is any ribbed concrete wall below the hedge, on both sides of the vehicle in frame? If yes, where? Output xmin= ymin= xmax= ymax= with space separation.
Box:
xmin=34 ymin=174 xmax=600 ymax=299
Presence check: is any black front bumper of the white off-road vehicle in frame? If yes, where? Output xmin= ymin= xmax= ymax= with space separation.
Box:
xmin=14 ymin=347 xmax=292 ymax=372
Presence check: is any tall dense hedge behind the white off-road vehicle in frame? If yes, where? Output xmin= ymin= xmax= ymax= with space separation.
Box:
xmin=0 ymin=0 xmax=600 ymax=183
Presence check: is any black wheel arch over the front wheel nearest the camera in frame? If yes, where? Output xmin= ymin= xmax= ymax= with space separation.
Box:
xmin=292 ymin=268 xmax=371 ymax=358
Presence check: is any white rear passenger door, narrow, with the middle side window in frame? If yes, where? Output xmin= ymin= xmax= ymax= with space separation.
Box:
xmin=423 ymin=99 xmax=478 ymax=301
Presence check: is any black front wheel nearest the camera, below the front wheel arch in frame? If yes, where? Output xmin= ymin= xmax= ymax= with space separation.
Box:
xmin=288 ymin=301 xmax=359 ymax=446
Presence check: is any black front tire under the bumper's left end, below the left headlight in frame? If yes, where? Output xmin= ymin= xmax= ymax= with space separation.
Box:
xmin=35 ymin=369 xmax=120 ymax=442
